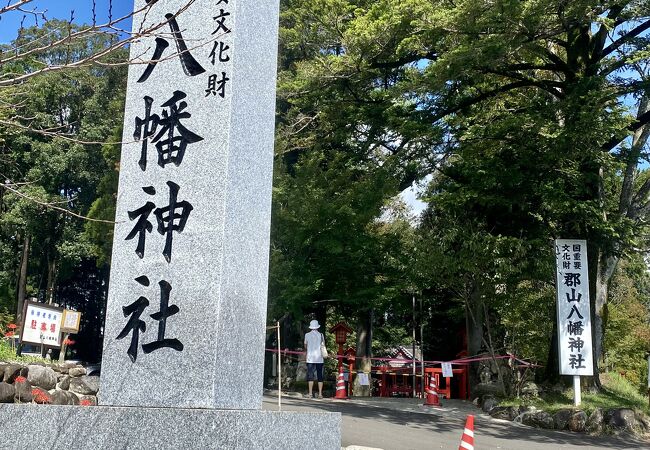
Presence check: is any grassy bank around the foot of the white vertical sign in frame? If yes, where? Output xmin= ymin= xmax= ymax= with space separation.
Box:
xmin=499 ymin=372 xmax=650 ymax=414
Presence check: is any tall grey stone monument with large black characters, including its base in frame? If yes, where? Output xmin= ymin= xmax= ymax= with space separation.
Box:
xmin=0 ymin=0 xmax=340 ymax=449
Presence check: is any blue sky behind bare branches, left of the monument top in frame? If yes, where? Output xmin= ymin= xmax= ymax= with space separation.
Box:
xmin=0 ymin=0 xmax=133 ymax=44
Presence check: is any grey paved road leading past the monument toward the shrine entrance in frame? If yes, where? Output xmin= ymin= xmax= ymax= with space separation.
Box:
xmin=263 ymin=395 xmax=650 ymax=450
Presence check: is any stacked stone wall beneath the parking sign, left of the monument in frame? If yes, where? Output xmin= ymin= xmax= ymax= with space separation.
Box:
xmin=0 ymin=363 xmax=99 ymax=406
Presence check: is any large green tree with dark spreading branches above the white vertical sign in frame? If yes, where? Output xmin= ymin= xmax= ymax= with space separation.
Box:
xmin=279 ymin=0 xmax=650 ymax=390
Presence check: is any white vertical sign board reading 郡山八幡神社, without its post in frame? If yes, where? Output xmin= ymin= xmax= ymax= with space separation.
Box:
xmin=555 ymin=239 xmax=593 ymax=376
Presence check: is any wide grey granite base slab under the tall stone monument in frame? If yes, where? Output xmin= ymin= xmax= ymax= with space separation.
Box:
xmin=0 ymin=404 xmax=341 ymax=450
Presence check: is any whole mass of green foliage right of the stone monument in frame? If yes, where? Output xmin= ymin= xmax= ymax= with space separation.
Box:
xmin=270 ymin=0 xmax=648 ymax=394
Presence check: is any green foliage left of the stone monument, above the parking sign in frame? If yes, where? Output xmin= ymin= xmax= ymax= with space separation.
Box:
xmin=0 ymin=20 xmax=127 ymax=360
